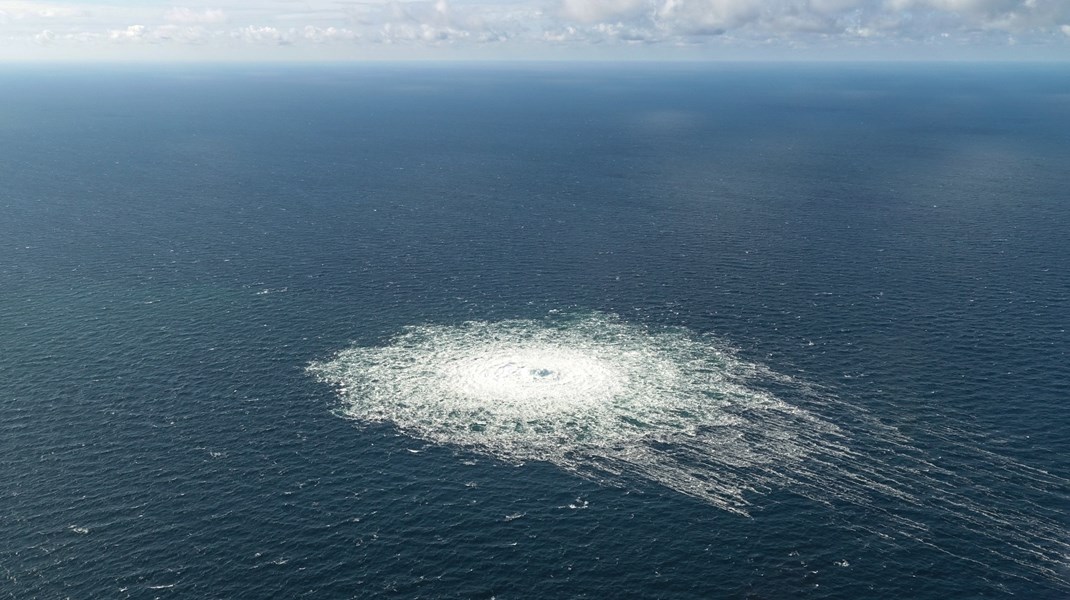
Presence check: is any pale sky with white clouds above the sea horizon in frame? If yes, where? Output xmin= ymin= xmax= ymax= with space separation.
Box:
xmin=0 ymin=0 xmax=1070 ymax=62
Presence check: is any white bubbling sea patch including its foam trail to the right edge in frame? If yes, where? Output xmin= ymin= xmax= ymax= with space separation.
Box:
xmin=308 ymin=312 xmax=1070 ymax=587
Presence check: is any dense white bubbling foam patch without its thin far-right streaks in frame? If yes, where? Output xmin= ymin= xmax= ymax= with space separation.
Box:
xmin=310 ymin=314 xmax=843 ymax=512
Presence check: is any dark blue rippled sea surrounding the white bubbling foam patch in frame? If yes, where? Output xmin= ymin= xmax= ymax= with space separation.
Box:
xmin=0 ymin=66 xmax=1070 ymax=599
